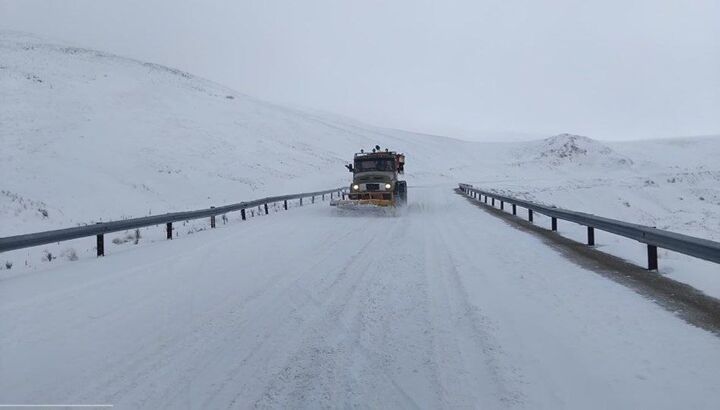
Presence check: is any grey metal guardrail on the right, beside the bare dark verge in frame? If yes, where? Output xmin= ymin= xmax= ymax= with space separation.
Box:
xmin=459 ymin=184 xmax=720 ymax=270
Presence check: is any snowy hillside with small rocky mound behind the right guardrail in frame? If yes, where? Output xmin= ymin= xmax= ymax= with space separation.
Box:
xmin=473 ymin=134 xmax=720 ymax=240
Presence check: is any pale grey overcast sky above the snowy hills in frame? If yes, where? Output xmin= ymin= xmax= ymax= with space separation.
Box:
xmin=0 ymin=0 xmax=720 ymax=139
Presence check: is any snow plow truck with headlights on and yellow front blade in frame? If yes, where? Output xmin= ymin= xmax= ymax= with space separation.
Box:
xmin=331 ymin=145 xmax=407 ymax=209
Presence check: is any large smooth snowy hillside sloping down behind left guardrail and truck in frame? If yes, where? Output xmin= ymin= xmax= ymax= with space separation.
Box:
xmin=0 ymin=32 xmax=484 ymax=235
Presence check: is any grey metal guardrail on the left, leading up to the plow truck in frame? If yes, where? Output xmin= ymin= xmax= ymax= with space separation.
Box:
xmin=0 ymin=188 xmax=347 ymax=256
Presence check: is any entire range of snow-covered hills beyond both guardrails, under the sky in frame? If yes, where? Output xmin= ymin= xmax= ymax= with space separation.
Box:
xmin=0 ymin=32 xmax=720 ymax=294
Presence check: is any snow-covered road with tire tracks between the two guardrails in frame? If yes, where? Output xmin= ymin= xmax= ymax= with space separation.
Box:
xmin=0 ymin=187 xmax=720 ymax=409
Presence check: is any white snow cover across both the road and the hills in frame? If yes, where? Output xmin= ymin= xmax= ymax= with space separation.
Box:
xmin=0 ymin=32 xmax=720 ymax=409
